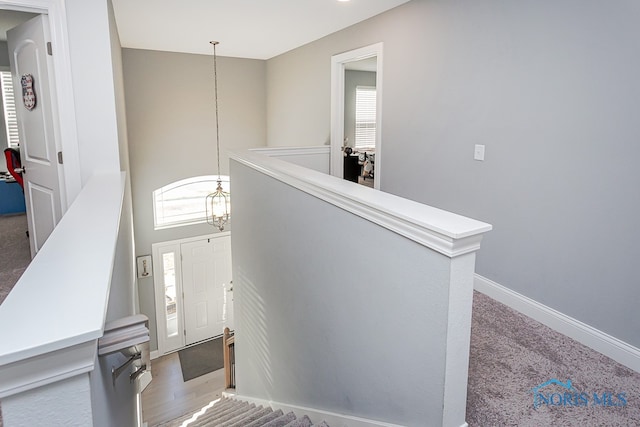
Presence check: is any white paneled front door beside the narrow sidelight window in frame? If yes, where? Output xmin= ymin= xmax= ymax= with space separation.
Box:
xmin=180 ymin=235 xmax=231 ymax=345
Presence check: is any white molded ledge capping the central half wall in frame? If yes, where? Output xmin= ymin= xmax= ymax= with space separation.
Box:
xmin=229 ymin=151 xmax=492 ymax=258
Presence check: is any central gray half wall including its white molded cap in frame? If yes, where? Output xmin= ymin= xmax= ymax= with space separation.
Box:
xmin=230 ymin=151 xmax=491 ymax=427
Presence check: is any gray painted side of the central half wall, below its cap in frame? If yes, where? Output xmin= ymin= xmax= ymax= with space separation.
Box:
xmin=231 ymin=161 xmax=475 ymax=426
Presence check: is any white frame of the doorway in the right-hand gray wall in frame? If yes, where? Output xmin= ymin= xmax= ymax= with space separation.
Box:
xmin=330 ymin=42 xmax=383 ymax=190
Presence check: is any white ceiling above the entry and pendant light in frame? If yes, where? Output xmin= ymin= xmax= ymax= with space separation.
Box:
xmin=112 ymin=0 xmax=409 ymax=59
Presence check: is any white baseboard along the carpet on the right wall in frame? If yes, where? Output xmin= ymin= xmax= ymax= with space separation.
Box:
xmin=474 ymin=274 xmax=640 ymax=372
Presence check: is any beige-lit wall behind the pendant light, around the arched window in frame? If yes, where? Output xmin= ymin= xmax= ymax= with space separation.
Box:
xmin=122 ymin=49 xmax=266 ymax=350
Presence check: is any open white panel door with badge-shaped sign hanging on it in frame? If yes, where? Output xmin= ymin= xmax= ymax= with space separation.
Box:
xmin=7 ymin=15 xmax=62 ymax=257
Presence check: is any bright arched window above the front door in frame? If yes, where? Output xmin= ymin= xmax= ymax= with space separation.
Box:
xmin=153 ymin=175 xmax=230 ymax=230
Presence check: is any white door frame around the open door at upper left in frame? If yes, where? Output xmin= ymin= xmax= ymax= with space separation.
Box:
xmin=0 ymin=0 xmax=82 ymax=207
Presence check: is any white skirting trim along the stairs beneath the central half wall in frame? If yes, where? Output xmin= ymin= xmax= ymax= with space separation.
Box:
xmin=228 ymin=393 xmax=452 ymax=427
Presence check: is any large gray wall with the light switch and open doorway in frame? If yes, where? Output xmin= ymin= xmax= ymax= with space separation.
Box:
xmin=267 ymin=0 xmax=640 ymax=347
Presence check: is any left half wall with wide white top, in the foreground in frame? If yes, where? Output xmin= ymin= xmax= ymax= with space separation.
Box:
xmin=0 ymin=172 xmax=127 ymax=427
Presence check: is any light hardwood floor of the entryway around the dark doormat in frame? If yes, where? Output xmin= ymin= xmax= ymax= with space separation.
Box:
xmin=142 ymin=352 xmax=225 ymax=427
